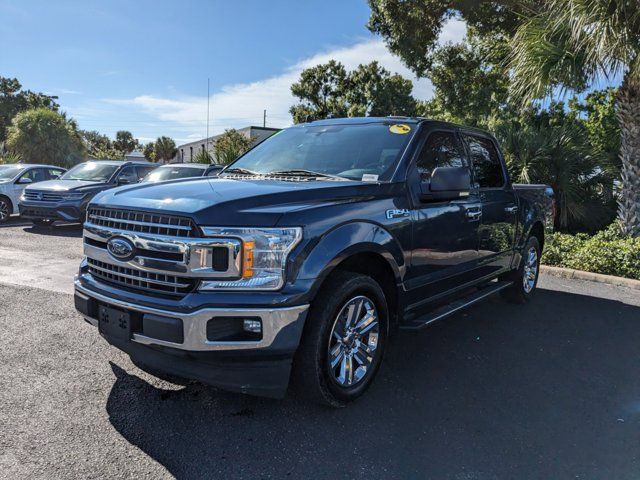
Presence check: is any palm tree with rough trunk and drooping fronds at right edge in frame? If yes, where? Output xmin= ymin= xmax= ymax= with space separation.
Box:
xmin=510 ymin=0 xmax=640 ymax=236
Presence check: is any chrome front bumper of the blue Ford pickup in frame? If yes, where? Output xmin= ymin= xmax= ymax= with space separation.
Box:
xmin=74 ymin=276 xmax=309 ymax=352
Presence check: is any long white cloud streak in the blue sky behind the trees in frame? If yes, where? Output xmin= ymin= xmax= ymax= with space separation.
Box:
xmin=104 ymin=19 xmax=466 ymax=141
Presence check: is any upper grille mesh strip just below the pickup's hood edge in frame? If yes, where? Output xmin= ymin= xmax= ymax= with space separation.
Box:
xmin=87 ymin=207 xmax=198 ymax=237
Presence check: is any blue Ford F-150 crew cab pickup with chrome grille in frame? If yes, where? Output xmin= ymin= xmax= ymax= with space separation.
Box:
xmin=75 ymin=117 xmax=554 ymax=406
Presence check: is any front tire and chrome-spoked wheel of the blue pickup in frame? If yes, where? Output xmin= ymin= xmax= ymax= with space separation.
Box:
xmin=293 ymin=272 xmax=389 ymax=407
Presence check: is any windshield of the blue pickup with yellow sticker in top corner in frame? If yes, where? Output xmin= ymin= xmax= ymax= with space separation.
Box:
xmin=226 ymin=123 xmax=415 ymax=180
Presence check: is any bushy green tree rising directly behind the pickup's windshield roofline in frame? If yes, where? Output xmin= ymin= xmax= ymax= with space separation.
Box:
xmin=289 ymin=60 xmax=417 ymax=123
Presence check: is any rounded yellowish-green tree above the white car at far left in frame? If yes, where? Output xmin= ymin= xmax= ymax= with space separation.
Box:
xmin=6 ymin=108 xmax=85 ymax=166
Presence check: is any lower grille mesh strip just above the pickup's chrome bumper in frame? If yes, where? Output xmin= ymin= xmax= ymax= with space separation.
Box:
xmin=87 ymin=258 xmax=196 ymax=296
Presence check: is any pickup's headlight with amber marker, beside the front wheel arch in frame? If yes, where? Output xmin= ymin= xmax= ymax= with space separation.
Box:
xmin=200 ymin=227 xmax=302 ymax=290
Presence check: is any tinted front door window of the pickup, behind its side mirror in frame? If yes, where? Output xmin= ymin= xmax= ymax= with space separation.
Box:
xmin=417 ymin=132 xmax=468 ymax=180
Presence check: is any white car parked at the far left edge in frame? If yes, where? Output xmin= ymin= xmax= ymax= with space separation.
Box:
xmin=0 ymin=163 xmax=66 ymax=223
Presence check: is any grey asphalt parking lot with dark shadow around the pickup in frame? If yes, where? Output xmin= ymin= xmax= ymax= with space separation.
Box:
xmin=0 ymin=220 xmax=640 ymax=480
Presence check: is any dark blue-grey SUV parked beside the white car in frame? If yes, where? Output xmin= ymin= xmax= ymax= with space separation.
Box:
xmin=19 ymin=160 xmax=157 ymax=226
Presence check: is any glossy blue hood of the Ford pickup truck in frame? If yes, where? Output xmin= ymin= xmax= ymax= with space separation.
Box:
xmin=92 ymin=178 xmax=384 ymax=226
